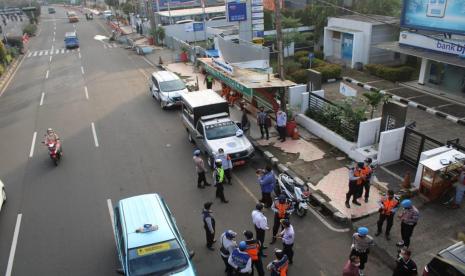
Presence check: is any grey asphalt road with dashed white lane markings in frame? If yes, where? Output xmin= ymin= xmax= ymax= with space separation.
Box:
xmin=0 ymin=4 xmax=389 ymax=275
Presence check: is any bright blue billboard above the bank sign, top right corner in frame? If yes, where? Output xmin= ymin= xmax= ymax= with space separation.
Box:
xmin=401 ymin=0 xmax=465 ymax=34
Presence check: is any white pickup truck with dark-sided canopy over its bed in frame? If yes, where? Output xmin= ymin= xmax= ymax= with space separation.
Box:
xmin=182 ymin=90 xmax=254 ymax=167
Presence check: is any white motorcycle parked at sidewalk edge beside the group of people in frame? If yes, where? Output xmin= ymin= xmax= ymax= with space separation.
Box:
xmin=275 ymin=173 xmax=310 ymax=217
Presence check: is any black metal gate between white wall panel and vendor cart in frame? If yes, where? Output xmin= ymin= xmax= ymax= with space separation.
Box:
xmin=400 ymin=127 xmax=444 ymax=167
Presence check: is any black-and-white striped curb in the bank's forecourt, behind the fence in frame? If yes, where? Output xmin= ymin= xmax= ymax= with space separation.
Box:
xmin=342 ymin=77 xmax=465 ymax=126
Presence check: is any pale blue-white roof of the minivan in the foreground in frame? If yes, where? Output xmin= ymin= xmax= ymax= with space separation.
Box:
xmin=119 ymin=194 xmax=175 ymax=249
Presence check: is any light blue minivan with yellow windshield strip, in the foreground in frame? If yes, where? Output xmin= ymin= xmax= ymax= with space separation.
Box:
xmin=114 ymin=194 xmax=196 ymax=276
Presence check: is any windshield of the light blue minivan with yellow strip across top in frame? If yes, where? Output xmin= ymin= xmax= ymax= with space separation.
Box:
xmin=128 ymin=240 xmax=187 ymax=276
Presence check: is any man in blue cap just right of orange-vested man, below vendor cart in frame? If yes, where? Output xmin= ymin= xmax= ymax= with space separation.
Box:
xmin=397 ymin=199 xmax=420 ymax=248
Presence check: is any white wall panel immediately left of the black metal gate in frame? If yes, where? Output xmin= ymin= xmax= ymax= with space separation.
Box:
xmin=377 ymin=127 xmax=405 ymax=165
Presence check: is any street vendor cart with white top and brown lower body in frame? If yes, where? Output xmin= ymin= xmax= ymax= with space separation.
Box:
xmin=420 ymin=149 xmax=465 ymax=200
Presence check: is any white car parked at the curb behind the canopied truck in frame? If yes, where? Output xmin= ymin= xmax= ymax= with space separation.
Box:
xmin=149 ymin=71 xmax=187 ymax=109
